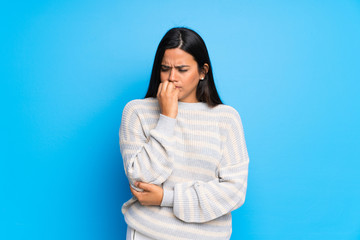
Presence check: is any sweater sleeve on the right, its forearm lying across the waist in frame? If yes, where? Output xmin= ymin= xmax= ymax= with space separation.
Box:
xmin=161 ymin=109 xmax=249 ymax=223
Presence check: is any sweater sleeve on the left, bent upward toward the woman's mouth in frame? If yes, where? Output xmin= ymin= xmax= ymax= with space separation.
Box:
xmin=119 ymin=102 xmax=176 ymax=191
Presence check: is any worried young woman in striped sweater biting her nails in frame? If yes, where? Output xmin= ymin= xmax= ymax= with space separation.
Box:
xmin=119 ymin=28 xmax=249 ymax=240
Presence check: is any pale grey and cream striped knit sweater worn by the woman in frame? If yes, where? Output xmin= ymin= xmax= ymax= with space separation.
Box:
xmin=119 ymin=98 xmax=249 ymax=240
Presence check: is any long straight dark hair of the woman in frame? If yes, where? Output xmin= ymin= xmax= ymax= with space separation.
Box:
xmin=145 ymin=27 xmax=223 ymax=107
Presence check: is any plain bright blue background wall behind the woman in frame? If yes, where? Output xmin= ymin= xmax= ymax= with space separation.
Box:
xmin=0 ymin=0 xmax=360 ymax=240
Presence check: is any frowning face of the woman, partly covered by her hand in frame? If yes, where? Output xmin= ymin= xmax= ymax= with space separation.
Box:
xmin=160 ymin=48 xmax=205 ymax=102
